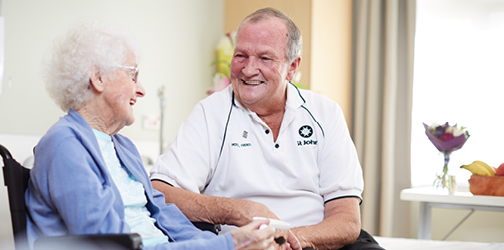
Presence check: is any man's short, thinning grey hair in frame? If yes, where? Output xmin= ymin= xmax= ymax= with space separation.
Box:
xmin=236 ymin=8 xmax=303 ymax=62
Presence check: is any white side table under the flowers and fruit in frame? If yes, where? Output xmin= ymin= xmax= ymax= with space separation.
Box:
xmin=401 ymin=187 xmax=504 ymax=240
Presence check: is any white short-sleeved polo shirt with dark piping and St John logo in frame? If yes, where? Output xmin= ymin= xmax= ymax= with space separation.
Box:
xmin=151 ymin=84 xmax=364 ymax=232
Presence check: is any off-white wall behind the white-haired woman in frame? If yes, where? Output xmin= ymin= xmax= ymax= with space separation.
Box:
xmin=0 ymin=0 xmax=224 ymax=246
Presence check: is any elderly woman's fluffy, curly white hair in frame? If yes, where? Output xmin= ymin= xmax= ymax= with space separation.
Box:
xmin=44 ymin=21 xmax=140 ymax=112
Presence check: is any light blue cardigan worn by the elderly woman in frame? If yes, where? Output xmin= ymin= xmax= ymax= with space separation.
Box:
xmin=25 ymin=110 xmax=234 ymax=250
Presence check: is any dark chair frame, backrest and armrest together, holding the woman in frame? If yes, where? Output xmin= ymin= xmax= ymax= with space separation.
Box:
xmin=0 ymin=144 xmax=143 ymax=250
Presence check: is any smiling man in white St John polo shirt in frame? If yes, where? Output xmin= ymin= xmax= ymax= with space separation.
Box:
xmin=151 ymin=8 xmax=381 ymax=249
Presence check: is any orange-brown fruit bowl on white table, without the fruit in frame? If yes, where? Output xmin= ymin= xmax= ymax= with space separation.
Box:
xmin=469 ymin=174 xmax=504 ymax=196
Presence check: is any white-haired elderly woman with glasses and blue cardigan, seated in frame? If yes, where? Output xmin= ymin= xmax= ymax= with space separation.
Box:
xmin=25 ymin=22 xmax=275 ymax=250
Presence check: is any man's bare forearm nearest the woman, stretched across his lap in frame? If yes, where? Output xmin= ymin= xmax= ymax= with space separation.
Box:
xmin=151 ymin=180 xmax=278 ymax=227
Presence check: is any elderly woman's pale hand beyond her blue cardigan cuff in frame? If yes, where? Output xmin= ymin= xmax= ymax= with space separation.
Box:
xmin=230 ymin=219 xmax=279 ymax=250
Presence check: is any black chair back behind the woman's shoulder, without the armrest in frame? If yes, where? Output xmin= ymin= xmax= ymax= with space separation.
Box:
xmin=0 ymin=145 xmax=30 ymax=249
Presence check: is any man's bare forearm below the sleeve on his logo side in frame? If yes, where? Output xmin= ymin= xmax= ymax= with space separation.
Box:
xmin=292 ymin=197 xmax=361 ymax=250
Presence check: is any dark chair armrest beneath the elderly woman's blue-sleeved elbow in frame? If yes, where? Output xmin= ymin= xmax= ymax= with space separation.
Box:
xmin=34 ymin=233 xmax=143 ymax=250
